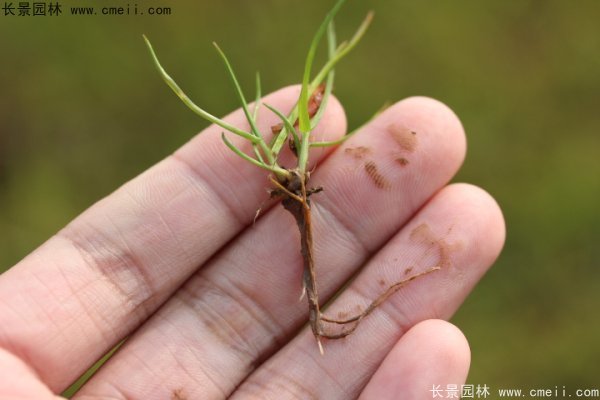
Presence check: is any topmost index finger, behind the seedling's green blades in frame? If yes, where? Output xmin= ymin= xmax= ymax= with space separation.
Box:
xmin=0 ymin=86 xmax=345 ymax=390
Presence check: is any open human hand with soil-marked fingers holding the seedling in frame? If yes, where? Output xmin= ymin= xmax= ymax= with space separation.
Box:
xmin=0 ymin=87 xmax=504 ymax=400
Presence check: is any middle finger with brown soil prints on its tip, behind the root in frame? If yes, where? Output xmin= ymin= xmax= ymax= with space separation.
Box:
xmin=76 ymin=98 xmax=465 ymax=399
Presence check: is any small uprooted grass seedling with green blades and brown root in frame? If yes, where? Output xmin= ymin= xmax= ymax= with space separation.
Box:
xmin=144 ymin=0 xmax=439 ymax=353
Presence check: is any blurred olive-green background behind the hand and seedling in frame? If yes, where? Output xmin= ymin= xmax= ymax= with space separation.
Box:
xmin=0 ymin=0 xmax=600 ymax=389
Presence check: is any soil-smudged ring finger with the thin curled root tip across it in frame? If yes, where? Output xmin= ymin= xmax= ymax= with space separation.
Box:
xmin=236 ymin=184 xmax=504 ymax=400
